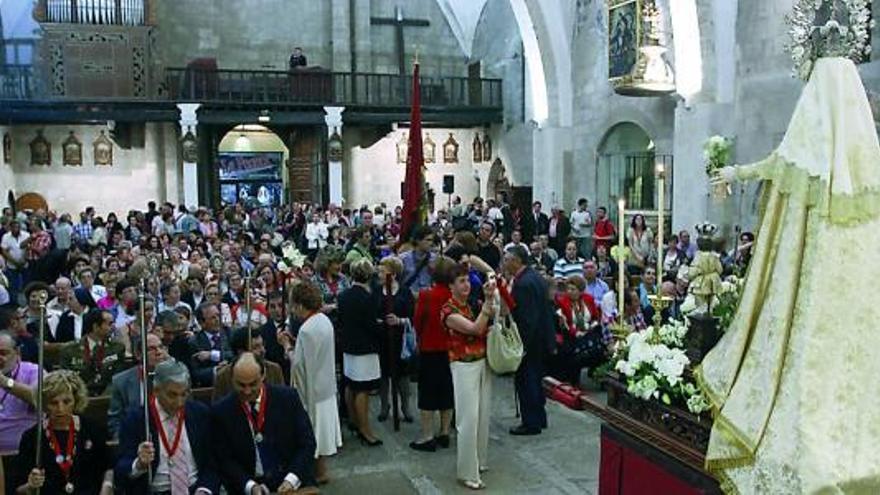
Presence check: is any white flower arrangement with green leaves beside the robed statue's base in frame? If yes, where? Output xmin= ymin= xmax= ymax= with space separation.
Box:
xmin=615 ymin=321 xmax=709 ymax=414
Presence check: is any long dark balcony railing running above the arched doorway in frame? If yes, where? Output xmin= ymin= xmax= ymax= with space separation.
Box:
xmin=166 ymin=67 xmax=502 ymax=108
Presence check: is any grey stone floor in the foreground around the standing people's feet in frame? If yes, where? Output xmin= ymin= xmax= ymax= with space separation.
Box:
xmin=322 ymin=378 xmax=599 ymax=495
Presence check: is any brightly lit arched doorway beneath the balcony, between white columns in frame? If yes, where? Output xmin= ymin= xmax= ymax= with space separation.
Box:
xmin=217 ymin=124 xmax=290 ymax=206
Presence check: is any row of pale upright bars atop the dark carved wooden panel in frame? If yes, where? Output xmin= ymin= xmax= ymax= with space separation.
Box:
xmin=40 ymin=0 xmax=148 ymax=26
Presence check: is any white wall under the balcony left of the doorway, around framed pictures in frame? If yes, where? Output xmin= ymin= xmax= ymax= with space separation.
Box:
xmin=0 ymin=123 xmax=182 ymax=216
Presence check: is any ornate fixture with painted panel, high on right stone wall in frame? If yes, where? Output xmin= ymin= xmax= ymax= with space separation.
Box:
xmin=608 ymin=0 xmax=675 ymax=96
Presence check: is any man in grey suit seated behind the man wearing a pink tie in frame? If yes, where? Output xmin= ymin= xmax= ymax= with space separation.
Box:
xmin=107 ymin=333 xmax=168 ymax=439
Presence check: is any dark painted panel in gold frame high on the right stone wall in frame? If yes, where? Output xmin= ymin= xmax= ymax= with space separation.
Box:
xmin=608 ymin=0 xmax=641 ymax=80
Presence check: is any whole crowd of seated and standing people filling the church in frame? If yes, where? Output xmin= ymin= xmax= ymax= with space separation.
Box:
xmin=0 ymin=198 xmax=753 ymax=495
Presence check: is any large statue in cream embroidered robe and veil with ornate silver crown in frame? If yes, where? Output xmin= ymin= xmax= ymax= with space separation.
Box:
xmin=697 ymin=0 xmax=880 ymax=494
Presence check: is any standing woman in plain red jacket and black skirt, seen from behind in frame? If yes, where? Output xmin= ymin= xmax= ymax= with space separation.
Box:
xmin=409 ymin=256 xmax=456 ymax=452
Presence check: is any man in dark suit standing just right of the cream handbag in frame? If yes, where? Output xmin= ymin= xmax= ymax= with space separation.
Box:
xmin=503 ymin=246 xmax=554 ymax=435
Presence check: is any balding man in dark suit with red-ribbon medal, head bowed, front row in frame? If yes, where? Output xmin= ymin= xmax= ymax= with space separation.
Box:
xmin=211 ymin=352 xmax=316 ymax=495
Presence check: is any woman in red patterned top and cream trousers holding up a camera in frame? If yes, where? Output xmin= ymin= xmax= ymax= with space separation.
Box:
xmin=440 ymin=265 xmax=496 ymax=490
